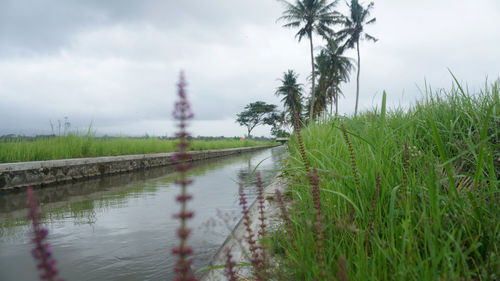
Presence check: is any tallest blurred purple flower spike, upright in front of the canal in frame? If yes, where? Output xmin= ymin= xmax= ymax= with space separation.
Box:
xmin=172 ymin=72 xmax=198 ymax=281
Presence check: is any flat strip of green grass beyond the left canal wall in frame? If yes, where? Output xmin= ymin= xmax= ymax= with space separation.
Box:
xmin=0 ymin=134 xmax=276 ymax=163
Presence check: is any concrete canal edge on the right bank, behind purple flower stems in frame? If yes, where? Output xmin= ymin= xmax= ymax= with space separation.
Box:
xmin=201 ymin=175 xmax=287 ymax=281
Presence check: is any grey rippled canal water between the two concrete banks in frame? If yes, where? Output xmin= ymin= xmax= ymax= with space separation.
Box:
xmin=0 ymin=146 xmax=285 ymax=281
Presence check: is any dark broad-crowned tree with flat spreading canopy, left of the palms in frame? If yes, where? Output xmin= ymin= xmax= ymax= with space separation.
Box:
xmin=236 ymin=101 xmax=277 ymax=138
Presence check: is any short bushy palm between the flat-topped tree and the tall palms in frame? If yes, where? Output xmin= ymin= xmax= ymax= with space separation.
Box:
xmin=275 ymin=69 xmax=302 ymax=123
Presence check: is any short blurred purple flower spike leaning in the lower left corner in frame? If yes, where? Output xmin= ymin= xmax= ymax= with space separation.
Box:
xmin=27 ymin=187 xmax=62 ymax=281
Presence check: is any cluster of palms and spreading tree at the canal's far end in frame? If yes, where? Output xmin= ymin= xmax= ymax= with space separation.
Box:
xmin=236 ymin=0 xmax=378 ymax=137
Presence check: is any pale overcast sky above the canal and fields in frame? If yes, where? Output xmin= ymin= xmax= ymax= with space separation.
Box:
xmin=0 ymin=0 xmax=500 ymax=137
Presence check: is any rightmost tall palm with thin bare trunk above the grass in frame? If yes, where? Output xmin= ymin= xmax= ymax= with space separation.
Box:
xmin=336 ymin=0 xmax=378 ymax=116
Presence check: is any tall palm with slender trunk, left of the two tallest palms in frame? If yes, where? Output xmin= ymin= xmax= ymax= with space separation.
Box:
xmin=278 ymin=0 xmax=340 ymax=121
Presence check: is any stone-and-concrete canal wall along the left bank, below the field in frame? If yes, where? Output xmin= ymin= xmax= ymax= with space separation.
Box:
xmin=0 ymin=146 xmax=278 ymax=193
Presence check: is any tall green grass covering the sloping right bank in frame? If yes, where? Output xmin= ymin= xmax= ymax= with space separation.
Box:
xmin=270 ymin=80 xmax=500 ymax=280
